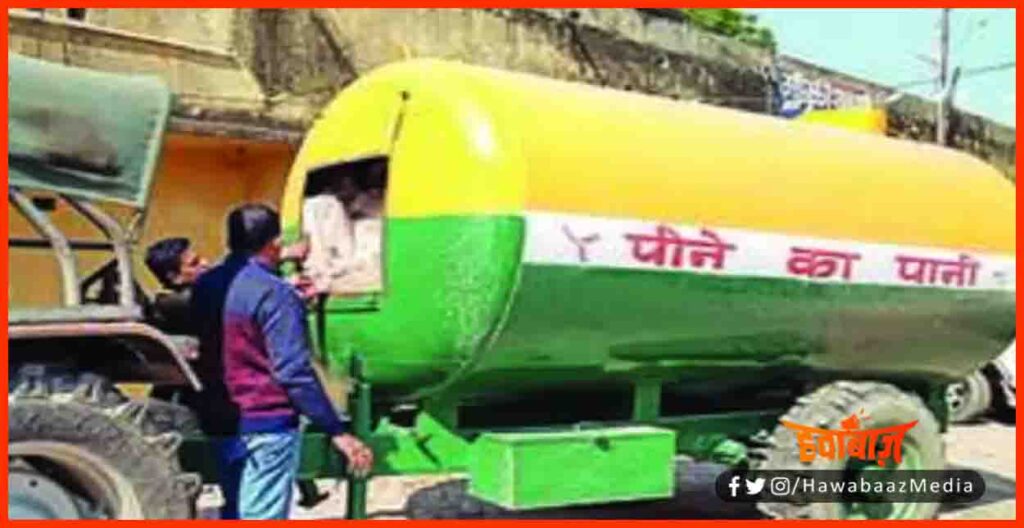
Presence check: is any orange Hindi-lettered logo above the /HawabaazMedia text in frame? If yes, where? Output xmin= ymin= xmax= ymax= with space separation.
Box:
xmin=779 ymin=410 xmax=918 ymax=467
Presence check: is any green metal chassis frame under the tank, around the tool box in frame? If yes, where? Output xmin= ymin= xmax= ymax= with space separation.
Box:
xmin=181 ymin=368 xmax=784 ymax=519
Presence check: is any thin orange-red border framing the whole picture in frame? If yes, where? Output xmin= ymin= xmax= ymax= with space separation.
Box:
xmin=0 ymin=0 xmax=1024 ymax=528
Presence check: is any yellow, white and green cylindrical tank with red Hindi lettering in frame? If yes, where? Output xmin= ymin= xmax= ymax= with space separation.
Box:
xmin=283 ymin=60 xmax=1016 ymax=400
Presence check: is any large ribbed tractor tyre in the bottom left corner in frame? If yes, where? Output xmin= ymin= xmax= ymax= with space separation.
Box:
xmin=7 ymin=365 xmax=200 ymax=519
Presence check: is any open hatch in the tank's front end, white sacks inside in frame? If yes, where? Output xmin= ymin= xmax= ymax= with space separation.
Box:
xmin=302 ymin=157 xmax=388 ymax=297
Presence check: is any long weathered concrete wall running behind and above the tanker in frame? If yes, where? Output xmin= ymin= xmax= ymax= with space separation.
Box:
xmin=11 ymin=9 xmax=1016 ymax=173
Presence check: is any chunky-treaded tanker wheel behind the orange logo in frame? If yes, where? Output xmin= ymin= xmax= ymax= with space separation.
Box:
xmin=751 ymin=382 xmax=946 ymax=519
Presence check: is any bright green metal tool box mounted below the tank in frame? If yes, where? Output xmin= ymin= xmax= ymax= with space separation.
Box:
xmin=469 ymin=427 xmax=676 ymax=510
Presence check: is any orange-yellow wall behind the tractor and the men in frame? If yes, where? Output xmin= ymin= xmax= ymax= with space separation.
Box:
xmin=8 ymin=134 xmax=294 ymax=307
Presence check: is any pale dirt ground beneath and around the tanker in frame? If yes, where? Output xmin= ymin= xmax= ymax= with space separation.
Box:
xmin=200 ymin=422 xmax=1017 ymax=519
